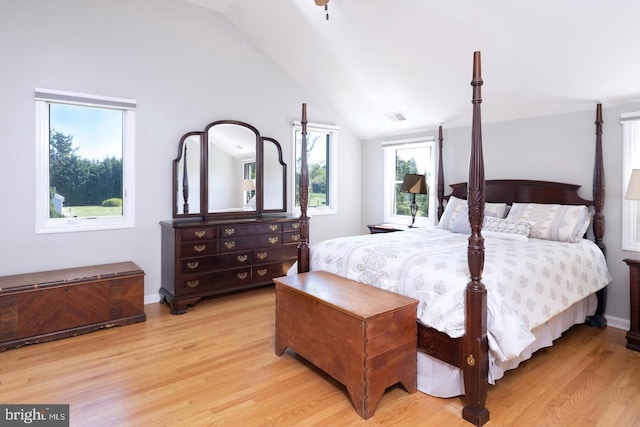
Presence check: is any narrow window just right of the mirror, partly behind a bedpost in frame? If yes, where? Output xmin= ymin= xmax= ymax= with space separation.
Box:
xmin=293 ymin=122 xmax=339 ymax=215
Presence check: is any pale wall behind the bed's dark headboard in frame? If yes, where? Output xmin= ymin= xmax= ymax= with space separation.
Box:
xmin=362 ymin=104 xmax=640 ymax=329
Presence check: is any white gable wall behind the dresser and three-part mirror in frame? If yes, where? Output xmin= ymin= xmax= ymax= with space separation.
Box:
xmin=0 ymin=0 xmax=360 ymax=301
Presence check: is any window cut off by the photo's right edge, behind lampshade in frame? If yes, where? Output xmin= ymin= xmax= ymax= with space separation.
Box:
xmin=621 ymin=112 xmax=640 ymax=252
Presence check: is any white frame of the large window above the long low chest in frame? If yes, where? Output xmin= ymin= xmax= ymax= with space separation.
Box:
xmin=34 ymin=88 xmax=136 ymax=234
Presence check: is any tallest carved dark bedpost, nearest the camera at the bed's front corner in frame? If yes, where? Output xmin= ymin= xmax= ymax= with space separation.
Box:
xmin=462 ymin=52 xmax=489 ymax=426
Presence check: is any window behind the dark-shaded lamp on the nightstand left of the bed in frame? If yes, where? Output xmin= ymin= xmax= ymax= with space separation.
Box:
xmin=382 ymin=138 xmax=435 ymax=226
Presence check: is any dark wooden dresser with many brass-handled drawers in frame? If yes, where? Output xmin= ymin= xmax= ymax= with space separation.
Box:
xmin=160 ymin=217 xmax=300 ymax=314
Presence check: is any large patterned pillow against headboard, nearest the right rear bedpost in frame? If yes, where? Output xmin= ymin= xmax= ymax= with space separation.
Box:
xmin=507 ymin=203 xmax=591 ymax=242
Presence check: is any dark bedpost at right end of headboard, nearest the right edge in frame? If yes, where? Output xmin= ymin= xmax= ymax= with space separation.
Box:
xmin=587 ymin=104 xmax=607 ymax=328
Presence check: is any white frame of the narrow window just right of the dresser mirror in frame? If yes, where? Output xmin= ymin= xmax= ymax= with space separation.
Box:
xmin=291 ymin=121 xmax=340 ymax=216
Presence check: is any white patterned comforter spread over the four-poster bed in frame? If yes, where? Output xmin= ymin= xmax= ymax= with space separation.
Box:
xmin=310 ymin=227 xmax=611 ymax=360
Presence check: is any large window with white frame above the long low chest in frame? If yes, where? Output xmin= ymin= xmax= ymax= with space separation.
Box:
xmin=35 ymin=89 xmax=136 ymax=233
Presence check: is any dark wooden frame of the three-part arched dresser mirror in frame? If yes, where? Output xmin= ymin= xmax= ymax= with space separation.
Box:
xmin=173 ymin=120 xmax=287 ymax=219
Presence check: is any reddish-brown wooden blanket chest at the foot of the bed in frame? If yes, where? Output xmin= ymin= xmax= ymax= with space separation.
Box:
xmin=273 ymin=271 xmax=418 ymax=419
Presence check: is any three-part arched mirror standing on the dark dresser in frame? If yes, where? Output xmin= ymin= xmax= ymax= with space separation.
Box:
xmin=173 ymin=120 xmax=287 ymax=219
